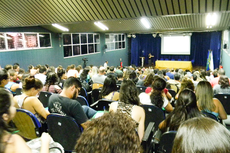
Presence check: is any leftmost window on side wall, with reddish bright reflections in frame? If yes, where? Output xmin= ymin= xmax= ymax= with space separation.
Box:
xmin=0 ymin=33 xmax=51 ymax=51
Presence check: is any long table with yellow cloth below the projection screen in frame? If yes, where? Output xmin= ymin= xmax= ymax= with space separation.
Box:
xmin=155 ymin=60 xmax=192 ymax=71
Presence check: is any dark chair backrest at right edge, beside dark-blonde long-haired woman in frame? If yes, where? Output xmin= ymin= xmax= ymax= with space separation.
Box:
xmin=214 ymin=94 xmax=230 ymax=115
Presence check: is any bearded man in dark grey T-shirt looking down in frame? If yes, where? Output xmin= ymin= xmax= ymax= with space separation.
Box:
xmin=48 ymin=77 xmax=96 ymax=125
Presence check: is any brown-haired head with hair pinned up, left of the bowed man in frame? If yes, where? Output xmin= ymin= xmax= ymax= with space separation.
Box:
xmin=22 ymin=76 xmax=43 ymax=95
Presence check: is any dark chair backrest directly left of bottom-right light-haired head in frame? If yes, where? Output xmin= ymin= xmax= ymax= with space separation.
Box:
xmin=157 ymin=131 xmax=176 ymax=153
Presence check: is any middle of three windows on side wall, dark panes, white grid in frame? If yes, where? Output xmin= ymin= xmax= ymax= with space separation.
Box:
xmin=63 ymin=33 xmax=100 ymax=57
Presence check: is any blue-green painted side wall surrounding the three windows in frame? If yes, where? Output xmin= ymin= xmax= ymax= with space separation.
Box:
xmin=0 ymin=27 xmax=128 ymax=70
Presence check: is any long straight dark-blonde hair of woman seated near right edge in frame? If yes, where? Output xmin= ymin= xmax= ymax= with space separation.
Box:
xmin=195 ymin=81 xmax=216 ymax=111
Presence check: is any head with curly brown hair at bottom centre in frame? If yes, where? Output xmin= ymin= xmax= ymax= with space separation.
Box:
xmin=75 ymin=112 xmax=141 ymax=153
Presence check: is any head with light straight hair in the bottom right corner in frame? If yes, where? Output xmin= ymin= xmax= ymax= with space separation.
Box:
xmin=172 ymin=117 xmax=230 ymax=153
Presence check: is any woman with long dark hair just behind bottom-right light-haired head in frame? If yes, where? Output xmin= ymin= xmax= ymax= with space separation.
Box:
xmin=159 ymin=89 xmax=201 ymax=132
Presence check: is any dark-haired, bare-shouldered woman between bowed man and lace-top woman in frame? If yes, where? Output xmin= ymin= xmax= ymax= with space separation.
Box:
xmin=100 ymin=75 xmax=119 ymax=101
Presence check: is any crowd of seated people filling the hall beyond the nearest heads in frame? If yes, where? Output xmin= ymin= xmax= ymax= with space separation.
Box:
xmin=0 ymin=62 xmax=230 ymax=152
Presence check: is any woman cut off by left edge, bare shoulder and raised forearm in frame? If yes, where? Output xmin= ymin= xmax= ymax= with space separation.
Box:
xmin=0 ymin=88 xmax=52 ymax=153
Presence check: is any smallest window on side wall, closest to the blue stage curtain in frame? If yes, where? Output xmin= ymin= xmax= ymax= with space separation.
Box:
xmin=105 ymin=34 xmax=125 ymax=51
